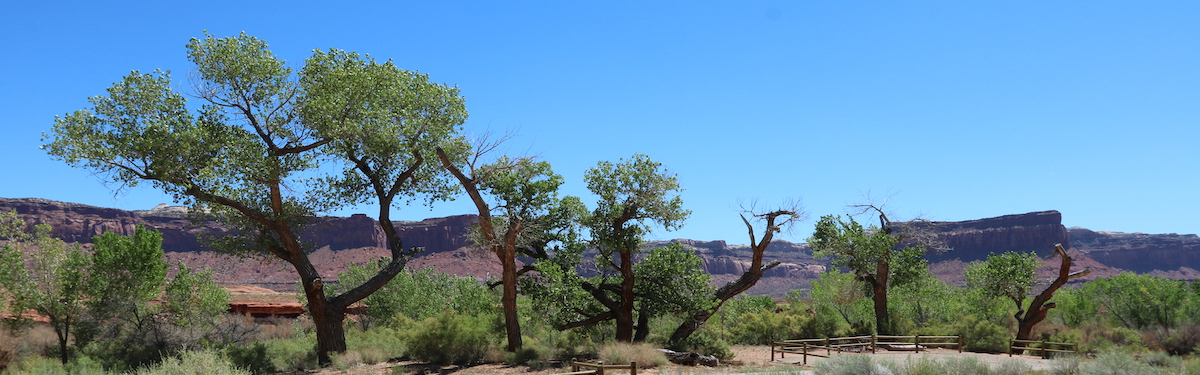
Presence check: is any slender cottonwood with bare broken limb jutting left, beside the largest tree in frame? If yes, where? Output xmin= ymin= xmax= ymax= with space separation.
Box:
xmin=437 ymin=139 xmax=563 ymax=351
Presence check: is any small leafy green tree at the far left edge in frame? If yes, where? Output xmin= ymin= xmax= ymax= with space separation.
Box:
xmin=0 ymin=212 xmax=91 ymax=364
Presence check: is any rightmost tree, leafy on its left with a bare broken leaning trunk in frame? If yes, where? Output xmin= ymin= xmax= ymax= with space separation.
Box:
xmin=965 ymin=244 xmax=1090 ymax=340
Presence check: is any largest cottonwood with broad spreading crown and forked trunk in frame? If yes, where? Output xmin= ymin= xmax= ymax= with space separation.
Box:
xmin=43 ymin=34 xmax=467 ymax=364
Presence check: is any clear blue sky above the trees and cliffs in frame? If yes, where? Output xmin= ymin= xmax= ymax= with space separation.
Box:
xmin=0 ymin=1 xmax=1200 ymax=243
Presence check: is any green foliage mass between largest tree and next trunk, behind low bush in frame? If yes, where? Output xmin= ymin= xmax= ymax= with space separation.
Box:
xmin=338 ymin=258 xmax=499 ymax=328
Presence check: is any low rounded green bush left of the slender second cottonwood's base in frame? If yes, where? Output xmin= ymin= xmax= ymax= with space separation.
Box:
xmin=402 ymin=311 xmax=498 ymax=364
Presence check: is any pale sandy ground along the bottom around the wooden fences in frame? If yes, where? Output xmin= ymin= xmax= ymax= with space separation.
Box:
xmin=304 ymin=346 xmax=1052 ymax=375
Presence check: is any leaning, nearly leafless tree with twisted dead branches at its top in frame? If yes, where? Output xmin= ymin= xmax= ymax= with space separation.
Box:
xmin=668 ymin=204 xmax=804 ymax=344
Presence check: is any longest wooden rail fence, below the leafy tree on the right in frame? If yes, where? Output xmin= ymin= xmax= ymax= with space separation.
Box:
xmin=770 ymin=334 xmax=962 ymax=364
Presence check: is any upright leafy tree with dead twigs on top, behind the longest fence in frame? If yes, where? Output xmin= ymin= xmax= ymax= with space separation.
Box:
xmin=808 ymin=213 xmax=925 ymax=333
